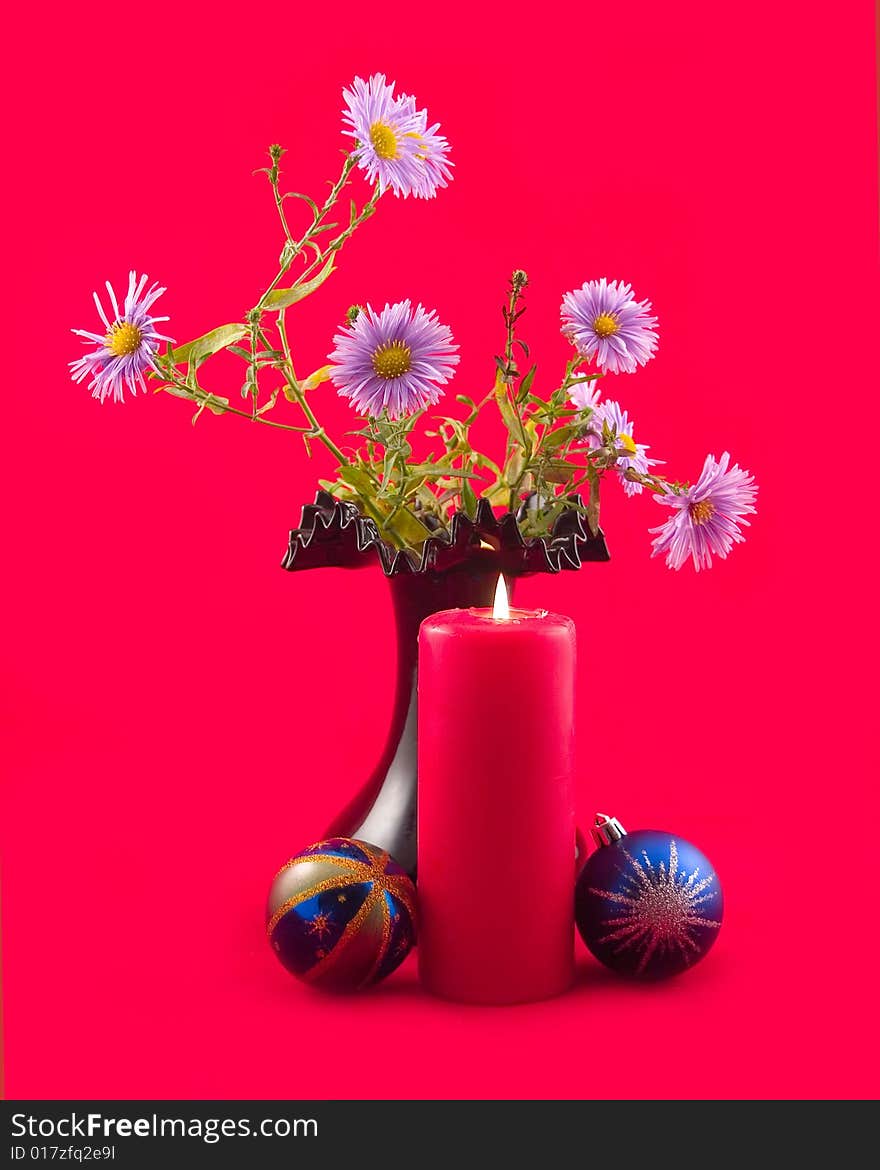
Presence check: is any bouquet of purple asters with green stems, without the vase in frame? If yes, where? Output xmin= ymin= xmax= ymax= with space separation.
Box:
xmin=70 ymin=74 xmax=757 ymax=571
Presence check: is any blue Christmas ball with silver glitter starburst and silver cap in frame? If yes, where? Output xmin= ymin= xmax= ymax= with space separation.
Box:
xmin=575 ymin=814 xmax=724 ymax=979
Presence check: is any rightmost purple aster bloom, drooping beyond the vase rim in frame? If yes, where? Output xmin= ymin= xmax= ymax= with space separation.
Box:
xmin=651 ymin=452 xmax=758 ymax=572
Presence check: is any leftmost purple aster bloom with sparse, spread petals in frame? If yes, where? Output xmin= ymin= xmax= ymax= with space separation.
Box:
xmin=70 ymin=271 xmax=172 ymax=402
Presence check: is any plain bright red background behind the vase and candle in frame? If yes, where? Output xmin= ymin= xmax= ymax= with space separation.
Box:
xmin=0 ymin=0 xmax=878 ymax=1097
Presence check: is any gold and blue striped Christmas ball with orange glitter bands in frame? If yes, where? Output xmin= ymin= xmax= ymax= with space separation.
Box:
xmin=267 ymin=837 xmax=417 ymax=991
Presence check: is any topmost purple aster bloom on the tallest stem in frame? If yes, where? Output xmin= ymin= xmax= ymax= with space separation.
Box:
xmin=343 ymin=74 xmax=452 ymax=199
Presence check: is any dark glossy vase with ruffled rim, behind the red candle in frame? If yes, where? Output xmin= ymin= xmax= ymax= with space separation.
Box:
xmin=282 ymin=491 xmax=609 ymax=876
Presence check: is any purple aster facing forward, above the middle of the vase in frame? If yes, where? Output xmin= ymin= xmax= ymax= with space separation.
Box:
xmin=330 ymin=301 xmax=459 ymax=419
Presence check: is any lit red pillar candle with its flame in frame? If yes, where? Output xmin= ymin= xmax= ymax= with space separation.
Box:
xmin=418 ymin=580 xmax=575 ymax=1004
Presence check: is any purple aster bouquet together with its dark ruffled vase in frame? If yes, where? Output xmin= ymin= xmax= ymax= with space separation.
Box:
xmin=71 ymin=74 xmax=756 ymax=873
